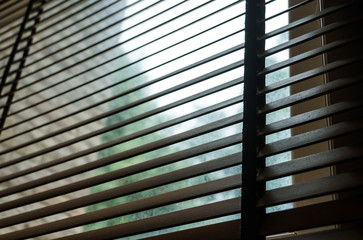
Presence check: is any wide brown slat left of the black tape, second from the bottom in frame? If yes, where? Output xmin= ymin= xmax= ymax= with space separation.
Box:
xmin=54 ymin=198 xmax=241 ymax=240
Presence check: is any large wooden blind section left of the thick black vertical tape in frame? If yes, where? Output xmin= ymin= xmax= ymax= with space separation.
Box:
xmin=0 ymin=0 xmax=245 ymax=239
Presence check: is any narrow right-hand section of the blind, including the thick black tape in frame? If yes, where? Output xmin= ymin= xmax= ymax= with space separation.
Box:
xmin=242 ymin=1 xmax=362 ymax=239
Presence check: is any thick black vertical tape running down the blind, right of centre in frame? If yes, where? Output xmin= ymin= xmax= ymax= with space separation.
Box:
xmin=241 ymin=0 xmax=265 ymax=240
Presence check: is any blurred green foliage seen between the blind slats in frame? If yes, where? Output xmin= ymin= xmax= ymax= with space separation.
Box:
xmin=84 ymin=54 xmax=225 ymax=231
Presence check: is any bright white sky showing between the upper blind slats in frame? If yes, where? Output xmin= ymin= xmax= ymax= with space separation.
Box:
xmin=120 ymin=0 xmax=288 ymax=126
